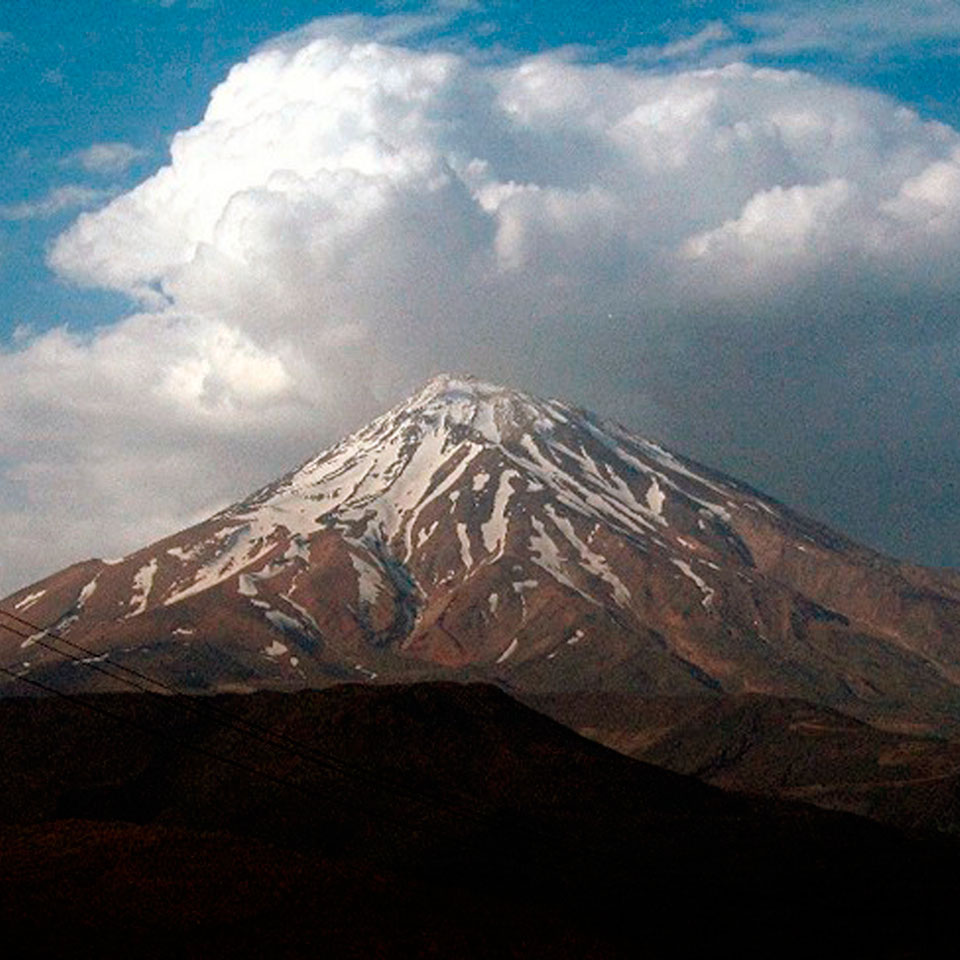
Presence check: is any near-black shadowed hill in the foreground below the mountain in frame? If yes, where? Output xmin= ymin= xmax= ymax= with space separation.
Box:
xmin=0 ymin=684 xmax=960 ymax=958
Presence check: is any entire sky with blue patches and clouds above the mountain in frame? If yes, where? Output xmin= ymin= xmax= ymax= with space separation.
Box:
xmin=0 ymin=0 xmax=960 ymax=593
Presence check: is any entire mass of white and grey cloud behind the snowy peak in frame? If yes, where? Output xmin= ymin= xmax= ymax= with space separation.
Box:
xmin=0 ymin=22 xmax=960 ymax=587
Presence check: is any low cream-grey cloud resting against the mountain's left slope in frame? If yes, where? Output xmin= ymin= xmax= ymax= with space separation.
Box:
xmin=0 ymin=314 xmax=348 ymax=591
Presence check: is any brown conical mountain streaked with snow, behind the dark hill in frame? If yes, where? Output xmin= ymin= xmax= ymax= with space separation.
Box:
xmin=0 ymin=376 xmax=960 ymax=732
